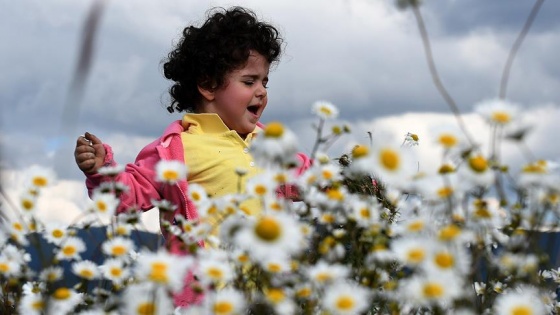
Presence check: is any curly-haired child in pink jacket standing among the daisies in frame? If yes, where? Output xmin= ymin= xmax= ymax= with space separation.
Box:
xmin=74 ymin=7 xmax=309 ymax=305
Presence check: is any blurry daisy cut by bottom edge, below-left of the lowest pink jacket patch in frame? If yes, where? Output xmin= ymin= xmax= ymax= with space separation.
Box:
xmin=121 ymin=282 xmax=174 ymax=315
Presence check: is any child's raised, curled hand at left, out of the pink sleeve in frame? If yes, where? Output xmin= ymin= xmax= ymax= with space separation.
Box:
xmin=74 ymin=132 xmax=106 ymax=174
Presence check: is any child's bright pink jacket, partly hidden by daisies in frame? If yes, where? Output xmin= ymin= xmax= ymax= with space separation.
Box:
xmin=86 ymin=120 xmax=311 ymax=305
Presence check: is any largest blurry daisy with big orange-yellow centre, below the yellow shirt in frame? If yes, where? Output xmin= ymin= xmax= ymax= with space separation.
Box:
xmin=235 ymin=213 xmax=303 ymax=258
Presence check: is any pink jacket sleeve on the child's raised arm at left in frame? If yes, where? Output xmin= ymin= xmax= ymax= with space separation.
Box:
xmin=86 ymin=139 xmax=162 ymax=213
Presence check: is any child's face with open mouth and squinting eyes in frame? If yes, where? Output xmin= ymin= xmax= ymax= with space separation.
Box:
xmin=202 ymin=51 xmax=270 ymax=137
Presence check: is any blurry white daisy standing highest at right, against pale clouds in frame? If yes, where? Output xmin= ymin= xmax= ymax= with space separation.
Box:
xmin=475 ymin=99 xmax=519 ymax=126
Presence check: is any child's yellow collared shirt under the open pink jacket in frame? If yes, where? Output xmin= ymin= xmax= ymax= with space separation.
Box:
xmin=181 ymin=114 xmax=262 ymax=223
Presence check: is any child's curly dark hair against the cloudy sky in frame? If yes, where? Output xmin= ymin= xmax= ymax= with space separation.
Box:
xmin=163 ymin=7 xmax=283 ymax=113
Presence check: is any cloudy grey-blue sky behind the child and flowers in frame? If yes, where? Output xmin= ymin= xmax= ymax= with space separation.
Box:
xmin=0 ymin=0 xmax=560 ymax=232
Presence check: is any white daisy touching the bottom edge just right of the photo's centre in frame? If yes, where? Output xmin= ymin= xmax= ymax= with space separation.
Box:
xmin=322 ymin=281 xmax=370 ymax=315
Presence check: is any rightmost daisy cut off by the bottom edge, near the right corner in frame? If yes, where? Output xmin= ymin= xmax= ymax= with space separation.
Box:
xmin=494 ymin=286 xmax=546 ymax=315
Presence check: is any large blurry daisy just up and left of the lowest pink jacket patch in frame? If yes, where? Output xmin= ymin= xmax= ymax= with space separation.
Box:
xmin=135 ymin=251 xmax=192 ymax=292
